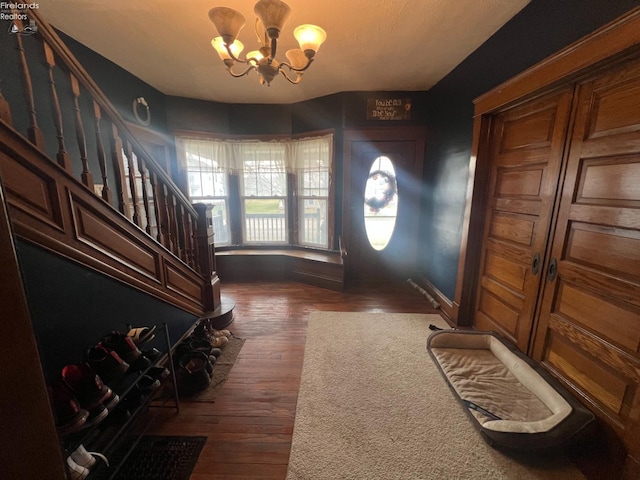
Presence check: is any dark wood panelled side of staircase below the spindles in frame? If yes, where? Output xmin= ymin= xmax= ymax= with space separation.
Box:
xmin=0 ymin=122 xmax=205 ymax=315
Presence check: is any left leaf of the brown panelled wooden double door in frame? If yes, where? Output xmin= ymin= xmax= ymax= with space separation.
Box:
xmin=474 ymin=89 xmax=572 ymax=352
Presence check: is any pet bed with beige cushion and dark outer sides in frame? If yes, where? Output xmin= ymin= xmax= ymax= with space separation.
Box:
xmin=427 ymin=330 xmax=595 ymax=450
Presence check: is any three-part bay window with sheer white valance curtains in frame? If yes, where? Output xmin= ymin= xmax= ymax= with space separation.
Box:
xmin=177 ymin=135 xmax=333 ymax=249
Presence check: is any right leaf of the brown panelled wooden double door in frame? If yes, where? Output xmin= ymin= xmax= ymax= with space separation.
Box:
xmin=533 ymin=59 xmax=640 ymax=454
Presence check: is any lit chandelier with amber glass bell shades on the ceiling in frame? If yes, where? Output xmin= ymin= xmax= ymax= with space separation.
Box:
xmin=209 ymin=0 xmax=327 ymax=85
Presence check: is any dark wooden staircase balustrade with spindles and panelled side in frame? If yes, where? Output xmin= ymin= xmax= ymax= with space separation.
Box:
xmin=0 ymin=10 xmax=220 ymax=321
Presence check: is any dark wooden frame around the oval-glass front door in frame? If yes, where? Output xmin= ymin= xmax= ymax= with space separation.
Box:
xmin=342 ymin=126 xmax=426 ymax=281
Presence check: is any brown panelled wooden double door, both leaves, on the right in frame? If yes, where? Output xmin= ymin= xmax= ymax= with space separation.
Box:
xmin=474 ymin=55 xmax=640 ymax=458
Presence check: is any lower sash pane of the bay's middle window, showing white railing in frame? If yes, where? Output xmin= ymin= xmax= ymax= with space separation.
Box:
xmin=244 ymin=198 xmax=287 ymax=242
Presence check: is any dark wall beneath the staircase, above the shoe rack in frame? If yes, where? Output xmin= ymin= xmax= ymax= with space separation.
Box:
xmin=16 ymin=241 xmax=197 ymax=380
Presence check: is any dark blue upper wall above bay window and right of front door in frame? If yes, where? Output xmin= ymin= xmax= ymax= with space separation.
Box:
xmin=52 ymin=0 xmax=640 ymax=306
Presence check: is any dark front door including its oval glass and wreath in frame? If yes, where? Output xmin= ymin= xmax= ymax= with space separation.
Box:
xmin=343 ymin=128 xmax=424 ymax=284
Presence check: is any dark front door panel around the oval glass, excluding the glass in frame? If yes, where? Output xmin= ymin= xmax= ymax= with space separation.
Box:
xmin=343 ymin=129 xmax=424 ymax=284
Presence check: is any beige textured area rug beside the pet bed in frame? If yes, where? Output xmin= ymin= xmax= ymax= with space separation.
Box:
xmin=287 ymin=312 xmax=584 ymax=480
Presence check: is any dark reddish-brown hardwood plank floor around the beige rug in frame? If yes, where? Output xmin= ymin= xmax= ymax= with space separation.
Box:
xmin=150 ymin=282 xmax=437 ymax=480
